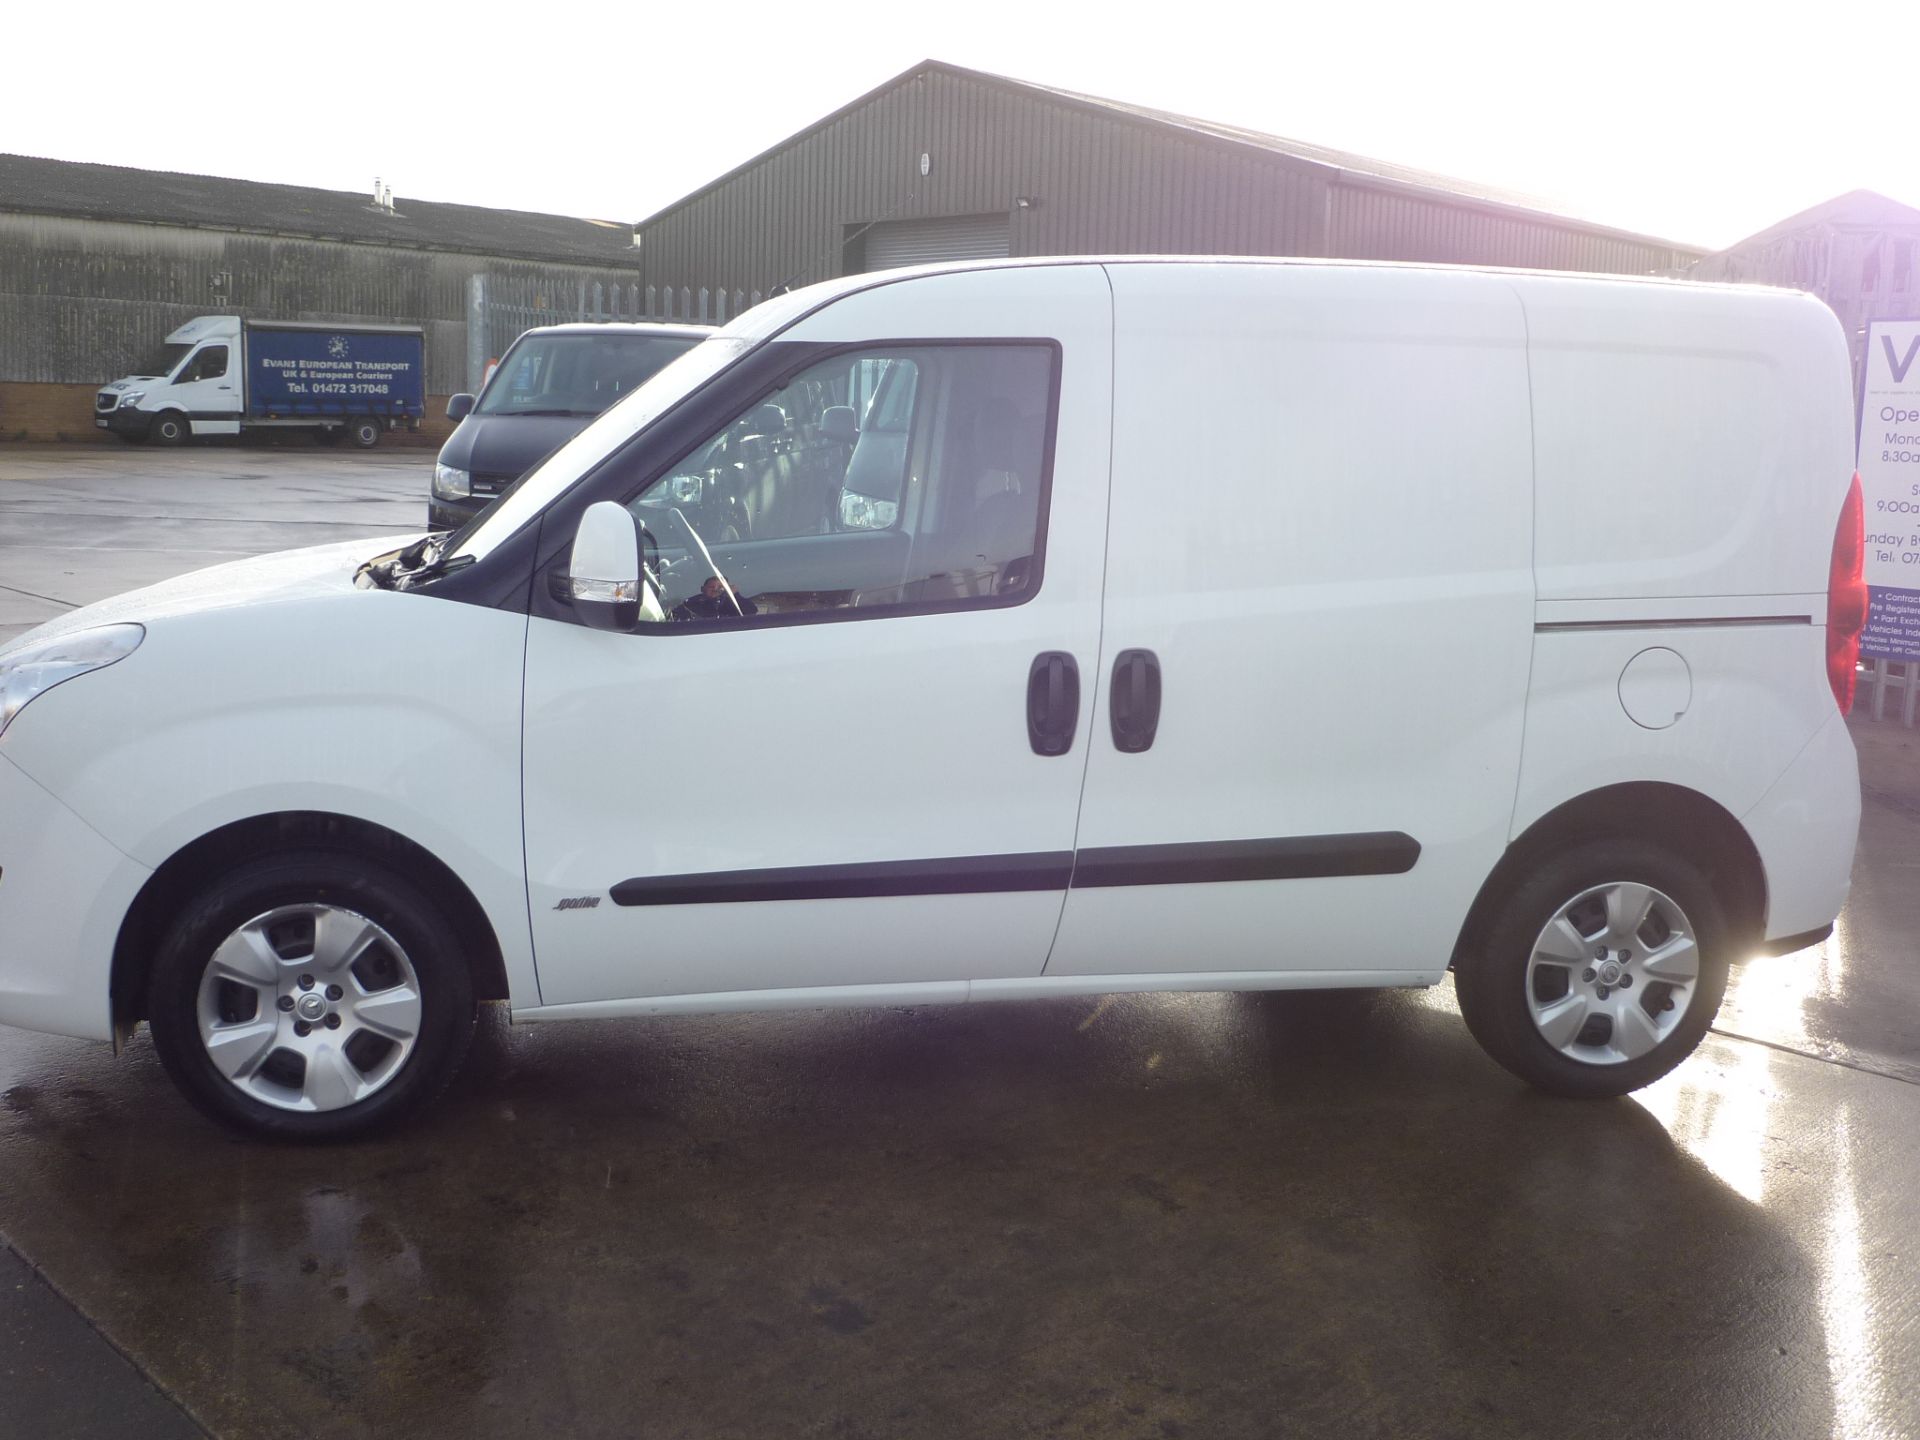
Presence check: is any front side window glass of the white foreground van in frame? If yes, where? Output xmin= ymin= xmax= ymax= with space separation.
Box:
xmin=630 ymin=344 xmax=1056 ymax=624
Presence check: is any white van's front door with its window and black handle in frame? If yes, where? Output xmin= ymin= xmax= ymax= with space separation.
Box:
xmin=524 ymin=267 xmax=1112 ymax=1006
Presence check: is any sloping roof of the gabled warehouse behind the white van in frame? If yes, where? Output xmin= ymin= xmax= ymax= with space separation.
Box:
xmin=639 ymin=60 xmax=1703 ymax=253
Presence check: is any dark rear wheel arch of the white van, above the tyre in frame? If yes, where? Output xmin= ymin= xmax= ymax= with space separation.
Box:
xmin=1448 ymin=781 xmax=1766 ymax=970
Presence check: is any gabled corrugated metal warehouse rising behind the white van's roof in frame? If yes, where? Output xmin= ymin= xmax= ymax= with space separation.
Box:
xmin=636 ymin=61 xmax=1703 ymax=305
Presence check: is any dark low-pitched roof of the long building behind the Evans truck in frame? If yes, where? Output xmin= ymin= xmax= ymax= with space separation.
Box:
xmin=0 ymin=156 xmax=634 ymax=263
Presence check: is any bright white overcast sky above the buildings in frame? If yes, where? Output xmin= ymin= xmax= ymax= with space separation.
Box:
xmin=0 ymin=0 xmax=1920 ymax=246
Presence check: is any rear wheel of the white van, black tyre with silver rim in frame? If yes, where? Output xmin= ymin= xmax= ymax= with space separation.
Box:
xmin=1455 ymin=841 xmax=1730 ymax=1098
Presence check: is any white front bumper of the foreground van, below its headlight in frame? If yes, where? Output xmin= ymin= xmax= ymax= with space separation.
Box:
xmin=0 ymin=755 xmax=152 ymax=1041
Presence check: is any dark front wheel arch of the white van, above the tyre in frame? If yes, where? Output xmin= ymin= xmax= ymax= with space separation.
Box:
xmin=109 ymin=810 xmax=509 ymax=1035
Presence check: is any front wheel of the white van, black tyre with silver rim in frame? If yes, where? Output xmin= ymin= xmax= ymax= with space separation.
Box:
xmin=148 ymin=851 xmax=474 ymax=1140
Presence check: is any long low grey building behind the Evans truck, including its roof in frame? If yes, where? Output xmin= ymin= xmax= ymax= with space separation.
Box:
xmin=0 ymin=156 xmax=643 ymax=440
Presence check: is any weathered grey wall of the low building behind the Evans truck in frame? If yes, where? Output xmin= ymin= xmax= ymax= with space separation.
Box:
xmin=0 ymin=215 xmax=637 ymax=394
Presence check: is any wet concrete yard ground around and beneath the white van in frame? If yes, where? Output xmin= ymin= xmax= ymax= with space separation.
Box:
xmin=0 ymin=447 xmax=1920 ymax=1440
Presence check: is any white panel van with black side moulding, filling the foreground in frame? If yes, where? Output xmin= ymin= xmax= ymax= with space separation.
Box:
xmin=0 ymin=259 xmax=1864 ymax=1137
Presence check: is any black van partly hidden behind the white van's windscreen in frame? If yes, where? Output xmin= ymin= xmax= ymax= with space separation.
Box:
xmin=426 ymin=324 xmax=712 ymax=530
